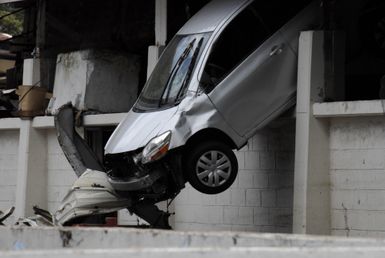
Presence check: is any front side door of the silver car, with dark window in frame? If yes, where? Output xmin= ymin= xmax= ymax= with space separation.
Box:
xmin=201 ymin=1 xmax=297 ymax=137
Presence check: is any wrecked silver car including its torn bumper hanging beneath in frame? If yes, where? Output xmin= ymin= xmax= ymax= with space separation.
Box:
xmin=55 ymin=0 xmax=319 ymax=227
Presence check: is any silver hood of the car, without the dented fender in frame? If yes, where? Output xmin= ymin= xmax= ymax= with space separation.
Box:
xmin=105 ymin=107 xmax=178 ymax=154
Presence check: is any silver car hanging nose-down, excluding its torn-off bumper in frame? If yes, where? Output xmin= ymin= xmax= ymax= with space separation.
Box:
xmin=105 ymin=0 xmax=318 ymax=194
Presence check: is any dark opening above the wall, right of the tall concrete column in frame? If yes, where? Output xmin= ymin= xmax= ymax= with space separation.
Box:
xmin=329 ymin=0 xmax=385 ymax=100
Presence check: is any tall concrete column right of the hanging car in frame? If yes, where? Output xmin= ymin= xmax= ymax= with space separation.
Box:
xmin=293 ymin=31 xmax=330 ymax=235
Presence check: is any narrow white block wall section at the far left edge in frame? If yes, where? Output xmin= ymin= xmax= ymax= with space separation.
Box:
xmin=0 ymin=130 xmax=19 ymax=221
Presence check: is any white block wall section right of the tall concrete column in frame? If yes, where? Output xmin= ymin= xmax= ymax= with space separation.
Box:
xmin=330 ymin=117 xmax=385 ymax=237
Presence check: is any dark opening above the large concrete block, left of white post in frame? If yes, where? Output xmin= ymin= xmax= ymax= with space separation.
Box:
xmin=42 ymin=0 xmax=155 ymax=56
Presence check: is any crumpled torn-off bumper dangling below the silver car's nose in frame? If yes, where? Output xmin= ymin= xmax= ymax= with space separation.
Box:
xmin=53 ymin=104 xmax=170 ymax=228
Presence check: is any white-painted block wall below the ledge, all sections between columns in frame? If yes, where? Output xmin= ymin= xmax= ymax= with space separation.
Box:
xmin=0 ymin=103 xmax=385 ymax=237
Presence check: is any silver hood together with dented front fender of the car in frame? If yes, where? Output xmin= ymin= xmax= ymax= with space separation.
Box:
xmin=105 ymin=92 xmax=244 ymax=154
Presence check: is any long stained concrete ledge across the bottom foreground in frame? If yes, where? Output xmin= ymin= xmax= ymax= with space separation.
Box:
xmin=0 ymin=227 xmax=385 ymax=251
